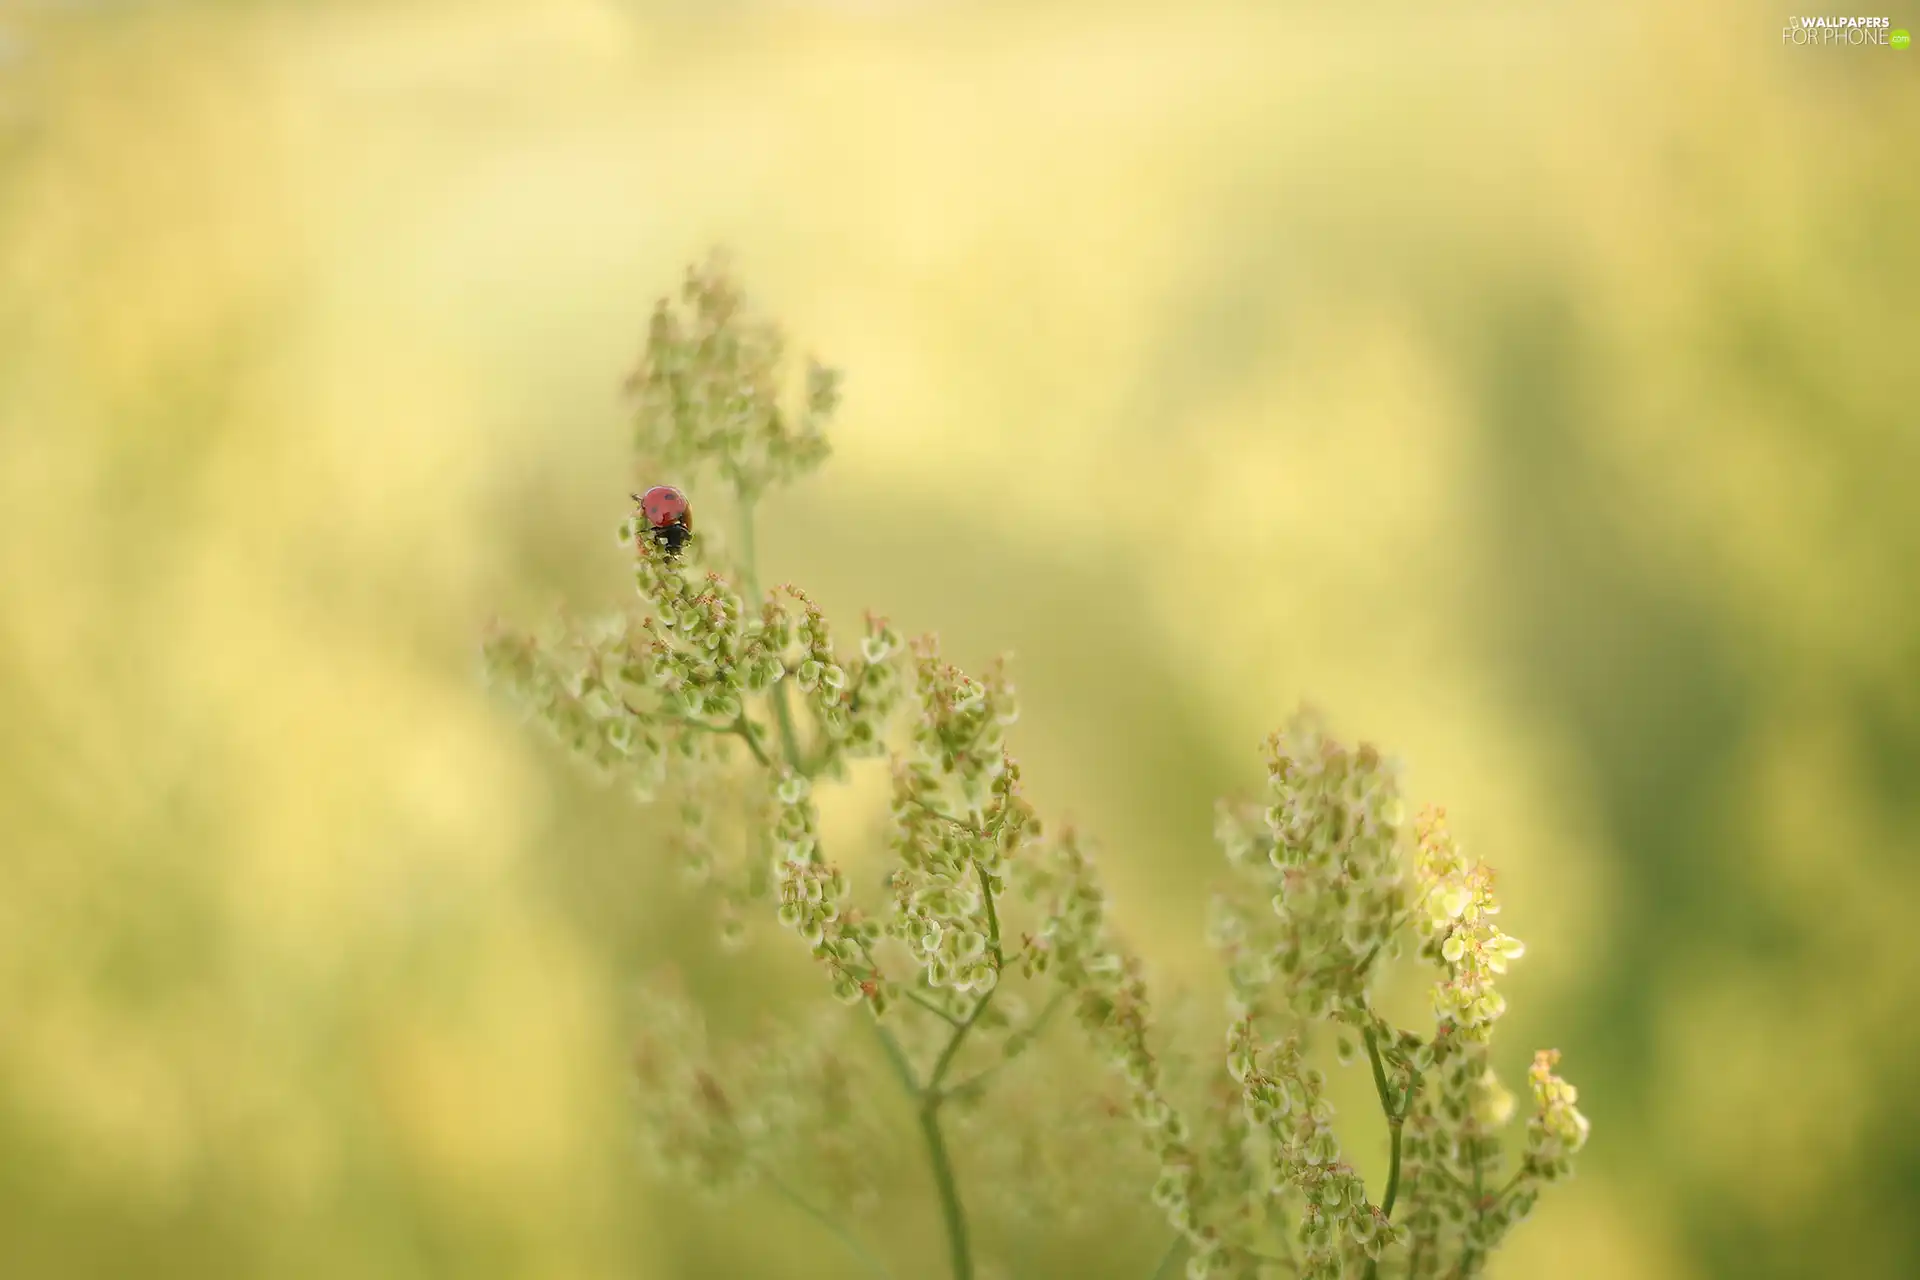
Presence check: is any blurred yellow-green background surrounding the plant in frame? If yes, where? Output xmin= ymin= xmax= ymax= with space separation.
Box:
xmin=0 ymin=0 xmax=1920 ymax=1280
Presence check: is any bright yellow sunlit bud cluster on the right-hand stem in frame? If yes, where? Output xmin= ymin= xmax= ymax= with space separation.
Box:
xmin=1415 ymin=808 xmax=1526 ymax=1038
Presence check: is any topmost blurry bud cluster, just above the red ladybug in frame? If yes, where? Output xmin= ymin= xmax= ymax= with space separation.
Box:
xmin=628 ymin=255 xmax=839 ymax=499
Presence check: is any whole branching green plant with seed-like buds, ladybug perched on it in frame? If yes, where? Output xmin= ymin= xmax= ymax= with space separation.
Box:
xmin=486 ymin=261 xmax=1588 ymax=1280
